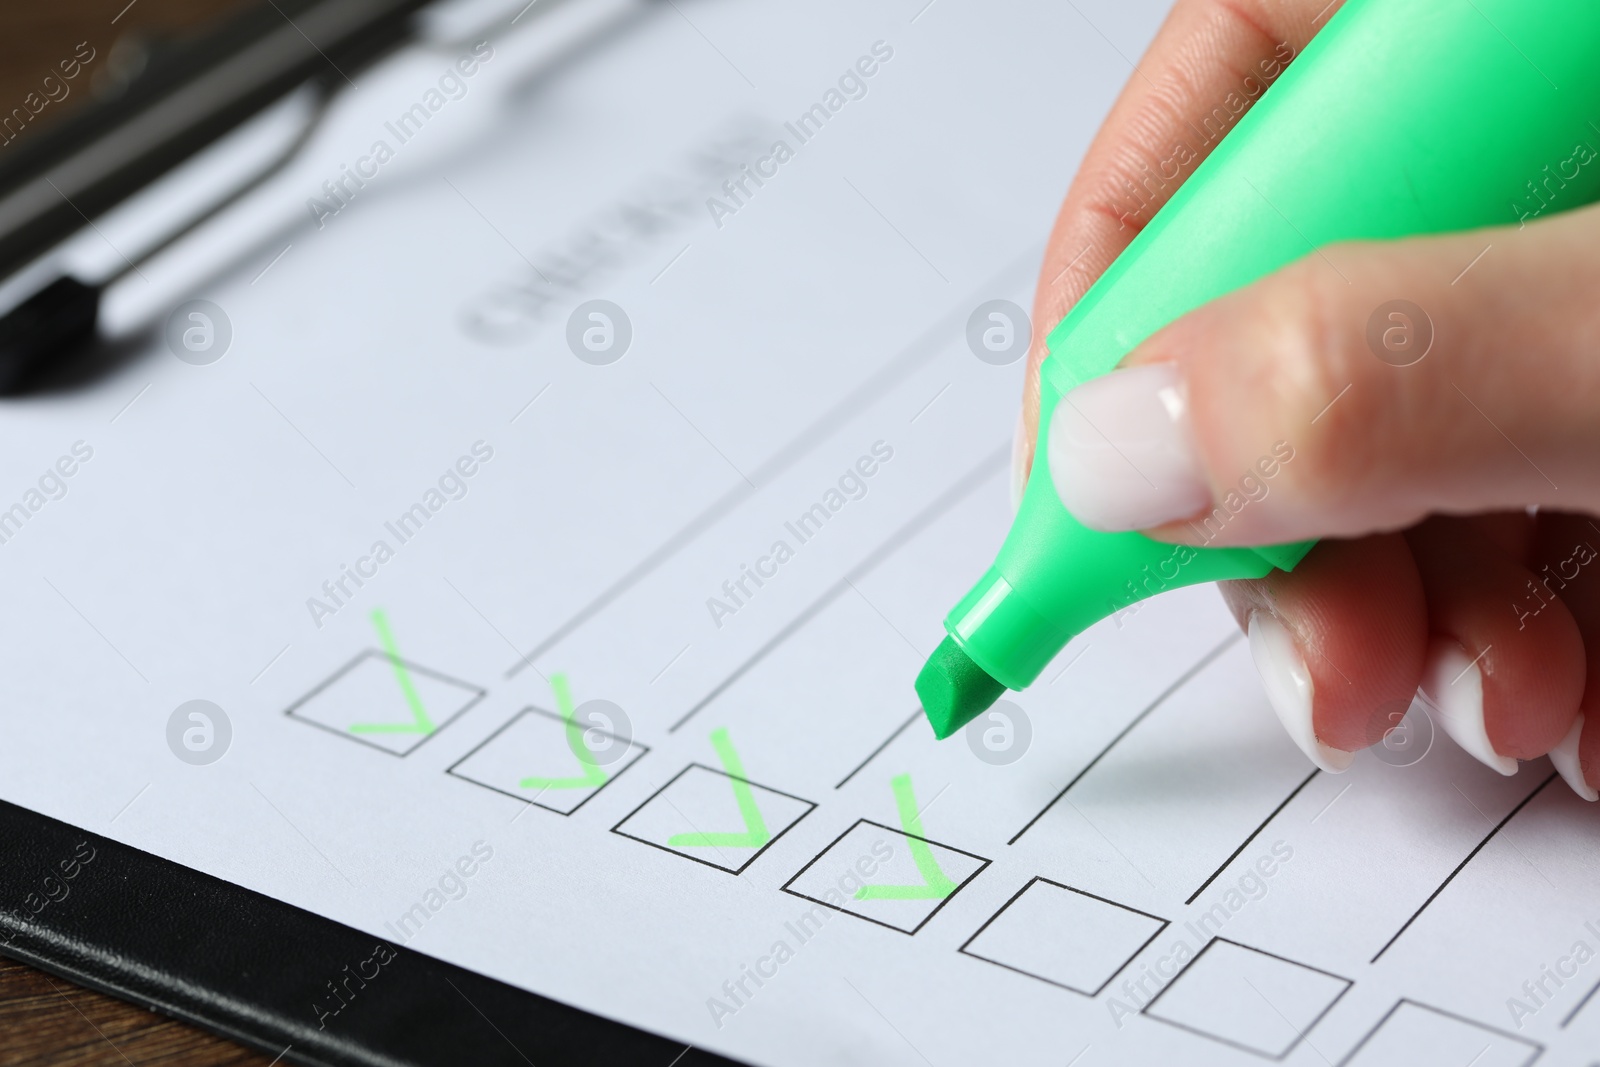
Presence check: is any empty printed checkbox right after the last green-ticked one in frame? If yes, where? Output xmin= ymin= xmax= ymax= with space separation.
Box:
xmin=960 ymin=878 xmax=1166 ymax=997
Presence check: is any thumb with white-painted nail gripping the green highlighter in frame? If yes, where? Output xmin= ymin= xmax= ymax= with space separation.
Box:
xmin=1048 ymin=208 xmax=1600 ymax=545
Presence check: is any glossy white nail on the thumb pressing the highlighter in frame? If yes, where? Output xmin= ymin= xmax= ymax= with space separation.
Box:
xmin=1050 ymin=363 xmax=1211 ymax=530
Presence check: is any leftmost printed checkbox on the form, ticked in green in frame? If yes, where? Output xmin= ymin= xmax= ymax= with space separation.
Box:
xmin=285 ymin=649 xmax=485 ymax=757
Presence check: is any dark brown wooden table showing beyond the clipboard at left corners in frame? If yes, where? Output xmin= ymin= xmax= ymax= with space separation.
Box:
xmin=0 ymin=0 xmax=284 ymax=1067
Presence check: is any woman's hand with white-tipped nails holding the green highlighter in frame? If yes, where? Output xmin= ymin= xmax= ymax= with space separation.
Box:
xmin=1016 ymin=0 xmax=1600 ymax=800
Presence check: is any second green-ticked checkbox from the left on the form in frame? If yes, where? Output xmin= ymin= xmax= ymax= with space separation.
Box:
xmin=448 ymin=707 xmax=650 ymax=816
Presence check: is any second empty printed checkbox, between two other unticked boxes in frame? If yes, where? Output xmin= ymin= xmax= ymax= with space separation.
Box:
xmin=1144 ymin=937 xmax=1350 ymax=1059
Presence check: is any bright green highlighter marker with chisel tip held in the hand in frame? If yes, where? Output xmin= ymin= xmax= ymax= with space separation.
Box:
xmin=917 ymin=0 xmax=1600 ymax=737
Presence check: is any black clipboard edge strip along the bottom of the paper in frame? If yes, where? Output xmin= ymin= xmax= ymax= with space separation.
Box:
xmin=0 ymin=801 xmax=734 ymax=1067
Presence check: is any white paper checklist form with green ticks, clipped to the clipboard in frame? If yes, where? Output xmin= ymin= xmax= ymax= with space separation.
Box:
xmin=0 ymin=0 xmax=1600 ymax=1065
